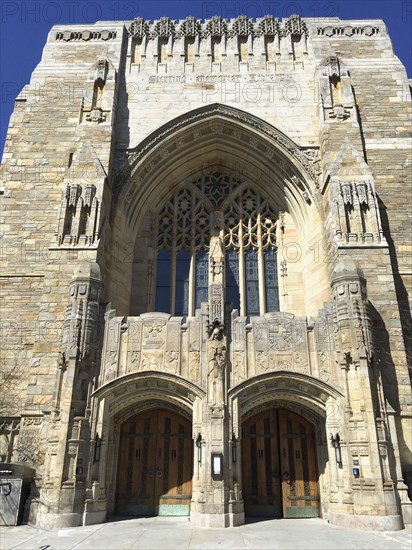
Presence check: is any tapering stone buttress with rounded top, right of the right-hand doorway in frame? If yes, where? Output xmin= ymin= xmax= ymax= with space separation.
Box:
xmin=329 ymin=258 xmax=402 ymax=530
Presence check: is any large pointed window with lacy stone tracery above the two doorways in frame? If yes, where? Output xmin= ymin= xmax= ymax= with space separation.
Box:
xmin=154 ymin=172 xmax=279 ymax=315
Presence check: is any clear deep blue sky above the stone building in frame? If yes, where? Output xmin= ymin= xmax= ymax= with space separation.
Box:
xmin=0 ymin=0 xmax=412 ymax=156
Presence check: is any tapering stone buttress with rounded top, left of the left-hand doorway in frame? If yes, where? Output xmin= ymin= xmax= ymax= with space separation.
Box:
xmin=37 ymin=261 xmax=101 ymax=528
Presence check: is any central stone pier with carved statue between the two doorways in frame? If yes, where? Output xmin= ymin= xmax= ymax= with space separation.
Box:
xmin=190 ymin=226 xmax=244 ymax=527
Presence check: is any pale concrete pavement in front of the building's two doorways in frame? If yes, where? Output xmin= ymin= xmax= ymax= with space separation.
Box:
xmin=0 ymin=517 xmax=412 ymax=550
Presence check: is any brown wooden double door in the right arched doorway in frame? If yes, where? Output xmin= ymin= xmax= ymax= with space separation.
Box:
xmin=242 ymin=408 xmax=319 ymax=518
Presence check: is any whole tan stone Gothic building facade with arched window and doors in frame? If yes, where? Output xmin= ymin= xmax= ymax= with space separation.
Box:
xmin=1 ymin=15 xmax=412 ymax=529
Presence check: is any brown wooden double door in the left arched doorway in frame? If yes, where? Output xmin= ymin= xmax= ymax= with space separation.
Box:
xmin=116 ymin=410 xmax=193 ymax=516
